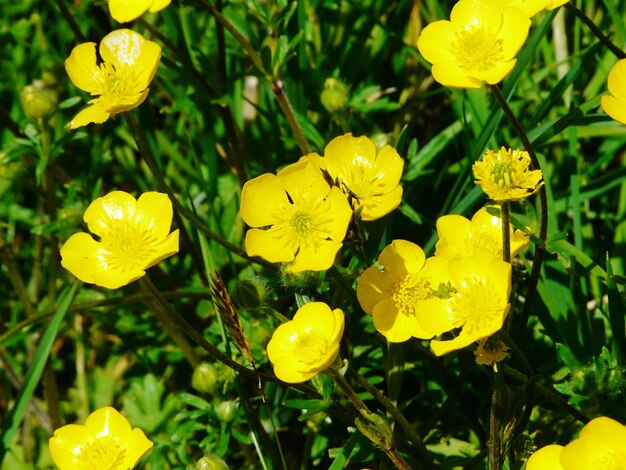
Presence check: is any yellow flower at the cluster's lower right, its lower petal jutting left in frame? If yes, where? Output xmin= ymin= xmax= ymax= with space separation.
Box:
xmin=430 ymin=247 xmax=511 ymax=356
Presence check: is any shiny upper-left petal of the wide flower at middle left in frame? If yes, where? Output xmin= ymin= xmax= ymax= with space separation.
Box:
xmin=83 ymin=191 xmax=137 ymax=237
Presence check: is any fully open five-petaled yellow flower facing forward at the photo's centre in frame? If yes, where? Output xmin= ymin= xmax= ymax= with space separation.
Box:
xmin=241 ymin=160 xmax=352 ymax=272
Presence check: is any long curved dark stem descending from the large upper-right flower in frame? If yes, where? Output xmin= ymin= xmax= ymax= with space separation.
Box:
xmin=491 ymin=85 xmax=548 ymax=344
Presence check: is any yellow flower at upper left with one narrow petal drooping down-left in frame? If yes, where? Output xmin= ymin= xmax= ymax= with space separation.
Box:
xmin=65 ymin=29 xmax=161 ymax=129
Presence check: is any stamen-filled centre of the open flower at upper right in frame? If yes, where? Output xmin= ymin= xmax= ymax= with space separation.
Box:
xmin=452 ymin=26 xmax=502 ymax=72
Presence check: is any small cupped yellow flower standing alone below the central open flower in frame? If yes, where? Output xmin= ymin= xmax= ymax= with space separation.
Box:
xmin=267 ymin=302 xmax=344 ymax=383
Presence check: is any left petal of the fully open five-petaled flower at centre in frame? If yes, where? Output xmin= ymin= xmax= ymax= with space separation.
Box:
xmin=241 ymin=173 xmax=290 ymax=229
